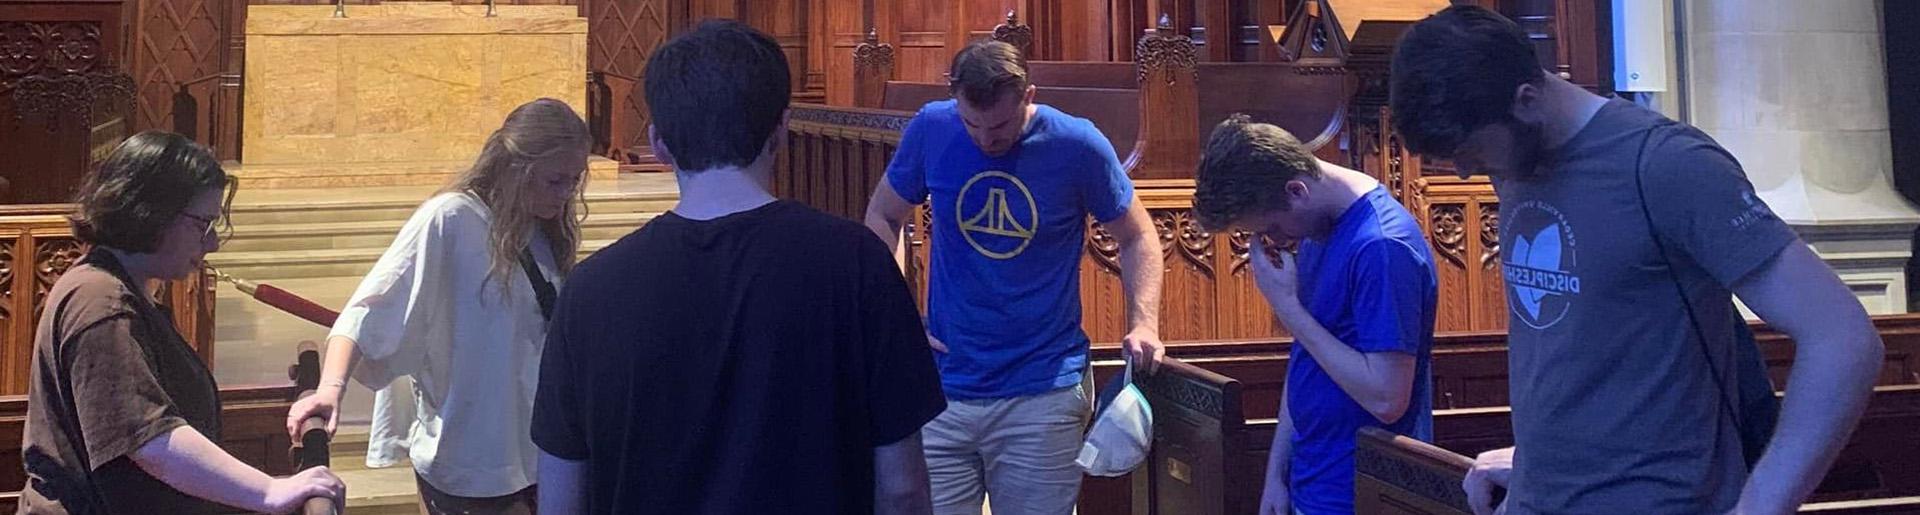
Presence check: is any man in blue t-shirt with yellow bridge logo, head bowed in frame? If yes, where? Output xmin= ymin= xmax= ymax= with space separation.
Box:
xmin=866 ymin=40 xmax=1164 ymax=513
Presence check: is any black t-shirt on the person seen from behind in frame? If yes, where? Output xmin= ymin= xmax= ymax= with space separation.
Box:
xmin=534 ymin=202 xmax=947 ymax=513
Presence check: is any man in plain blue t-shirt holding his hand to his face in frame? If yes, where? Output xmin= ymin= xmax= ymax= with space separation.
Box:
xmin=1194 ymin=115 xmax=1440 ymax=515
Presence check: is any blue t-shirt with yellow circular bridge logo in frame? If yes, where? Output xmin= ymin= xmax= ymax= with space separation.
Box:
xmin=887 ymin=100 xmax=1133 ymax=400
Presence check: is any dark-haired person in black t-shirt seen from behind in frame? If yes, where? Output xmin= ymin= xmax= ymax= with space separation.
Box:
xmin=534 ymin=21 xmax=947 ymax=513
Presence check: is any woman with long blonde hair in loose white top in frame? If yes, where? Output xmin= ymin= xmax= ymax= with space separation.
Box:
xmin=286 ymin=98 xmax=589 ymax=515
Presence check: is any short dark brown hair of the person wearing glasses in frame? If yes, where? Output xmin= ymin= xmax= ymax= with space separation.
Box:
xmin=67 ymin=131 xmax=234 ymax=252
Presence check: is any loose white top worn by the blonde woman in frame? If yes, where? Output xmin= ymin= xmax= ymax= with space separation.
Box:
xmin=332 ymin=192 xmax=561 ymax=498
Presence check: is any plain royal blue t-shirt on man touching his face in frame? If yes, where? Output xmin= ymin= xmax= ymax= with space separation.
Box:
xmin=1286 ymin=188 xmax=1440 ymax=515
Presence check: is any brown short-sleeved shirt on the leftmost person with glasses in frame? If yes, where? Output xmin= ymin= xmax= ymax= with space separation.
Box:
xmin=19 ymin=248 xmax=230 ymax=513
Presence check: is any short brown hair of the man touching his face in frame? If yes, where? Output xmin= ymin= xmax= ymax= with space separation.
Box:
xmin=1194 ymin=113 xmax=1321 ymax=231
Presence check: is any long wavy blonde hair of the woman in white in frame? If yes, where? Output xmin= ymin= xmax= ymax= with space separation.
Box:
xmin=442 ymin=98 xmax=593 ymax=284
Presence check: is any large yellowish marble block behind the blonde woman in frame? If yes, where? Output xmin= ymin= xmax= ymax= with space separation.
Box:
xmin=232 ymin=2 xmax=618 ymax=188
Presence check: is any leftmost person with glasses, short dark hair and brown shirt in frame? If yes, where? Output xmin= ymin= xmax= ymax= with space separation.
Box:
xmin=19 ymin=133 xmax=346 ymax=513
